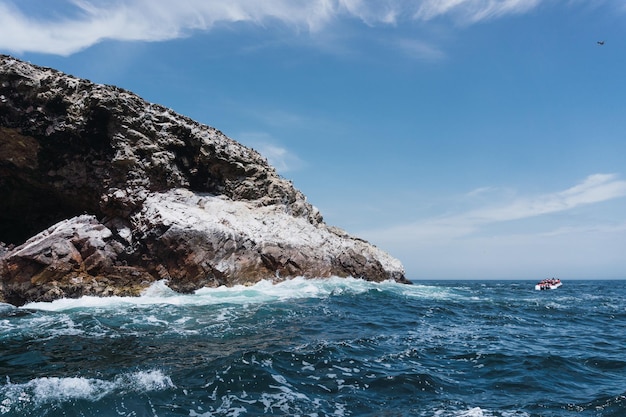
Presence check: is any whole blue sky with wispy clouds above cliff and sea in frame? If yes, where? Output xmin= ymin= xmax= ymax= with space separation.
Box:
xmin=0 ymin=0 xmax=626 ymax=279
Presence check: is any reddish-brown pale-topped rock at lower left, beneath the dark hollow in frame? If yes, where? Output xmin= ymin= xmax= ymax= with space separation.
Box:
xmin=0 ymin=215 xmax=155 ymax=305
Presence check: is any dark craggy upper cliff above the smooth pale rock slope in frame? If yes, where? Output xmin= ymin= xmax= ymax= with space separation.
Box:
xmin=0 ymin=56 xmax=321 ymax=242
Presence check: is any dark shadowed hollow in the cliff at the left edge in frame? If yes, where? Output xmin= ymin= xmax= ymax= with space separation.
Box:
xmin=0 ymin=127 xmax=100 ymax=244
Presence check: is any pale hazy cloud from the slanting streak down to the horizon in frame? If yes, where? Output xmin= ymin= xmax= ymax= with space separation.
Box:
xmin=357 ymin=174 xmax=626 ymax=279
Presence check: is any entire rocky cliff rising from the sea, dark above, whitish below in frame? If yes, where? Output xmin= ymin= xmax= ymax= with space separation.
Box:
xmin=0 ymin=55 xmax=407 ymax=305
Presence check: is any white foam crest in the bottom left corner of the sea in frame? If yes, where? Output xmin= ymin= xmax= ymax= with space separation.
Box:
xmin=0 ymin=370 xmax=175 ymax=414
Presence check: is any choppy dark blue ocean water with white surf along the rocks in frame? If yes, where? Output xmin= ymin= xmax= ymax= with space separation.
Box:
xmin=0 ymin=278 xmax=626 ymax=417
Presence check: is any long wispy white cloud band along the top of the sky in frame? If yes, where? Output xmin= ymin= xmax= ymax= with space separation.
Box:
xmin=0 ymin=0 xmax=546 ymax=55
